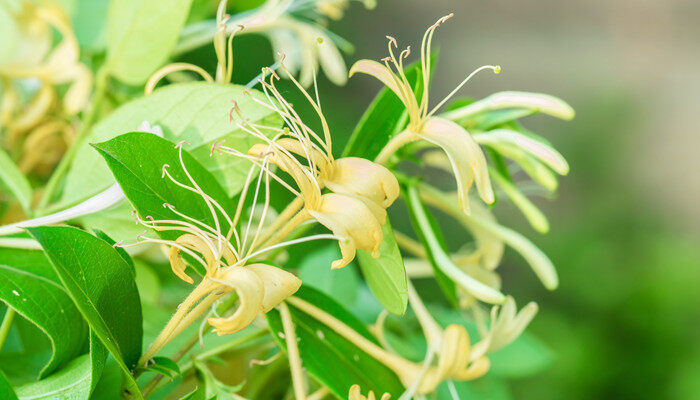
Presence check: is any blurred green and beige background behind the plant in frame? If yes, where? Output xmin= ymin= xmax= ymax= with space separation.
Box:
xmin=227 ymin=0 xmax=700 ymax=399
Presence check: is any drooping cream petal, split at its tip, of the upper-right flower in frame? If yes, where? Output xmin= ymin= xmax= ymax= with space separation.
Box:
xmin=417 ymin=117 xmax=494 ymax=214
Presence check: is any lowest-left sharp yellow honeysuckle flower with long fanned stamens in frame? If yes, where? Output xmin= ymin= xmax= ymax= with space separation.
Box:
xmin=117 ymin=142 xmax=366 ymax=365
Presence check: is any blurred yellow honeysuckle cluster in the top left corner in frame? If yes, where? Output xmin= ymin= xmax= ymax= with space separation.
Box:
xmin=0 ymin=1 xmax=92 ymax=173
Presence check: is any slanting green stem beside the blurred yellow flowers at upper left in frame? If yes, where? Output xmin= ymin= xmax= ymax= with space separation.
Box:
xmin=37 ymin=67 xmax=109 ymax=211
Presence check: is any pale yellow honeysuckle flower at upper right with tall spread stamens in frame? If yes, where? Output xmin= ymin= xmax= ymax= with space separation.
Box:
xmin=350 ymin=14 xmax=500 ymax=214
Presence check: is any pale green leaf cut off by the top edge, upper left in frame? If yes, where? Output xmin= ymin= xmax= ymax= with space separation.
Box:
xmin=106 ymin=0 xmax=192 ymax=85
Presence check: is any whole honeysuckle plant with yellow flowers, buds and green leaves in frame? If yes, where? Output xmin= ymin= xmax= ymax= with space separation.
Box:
xmin=0 ymin=0 xmax=574 ymax=400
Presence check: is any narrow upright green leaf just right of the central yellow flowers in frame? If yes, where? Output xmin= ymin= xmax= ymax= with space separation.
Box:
xmin=404 ymin=184 xmax=457 ymax=306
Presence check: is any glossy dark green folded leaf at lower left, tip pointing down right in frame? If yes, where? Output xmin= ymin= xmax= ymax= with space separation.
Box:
xmin=28 ymin=226 xmax=143 ymax=399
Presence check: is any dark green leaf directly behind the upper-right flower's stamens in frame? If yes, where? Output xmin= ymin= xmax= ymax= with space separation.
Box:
xmin=343 ymin=55 xmax=436 ymax=160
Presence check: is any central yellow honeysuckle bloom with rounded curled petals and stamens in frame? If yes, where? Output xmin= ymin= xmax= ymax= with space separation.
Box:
xmin=216 ymin=64 xmax=399 ymax=268
